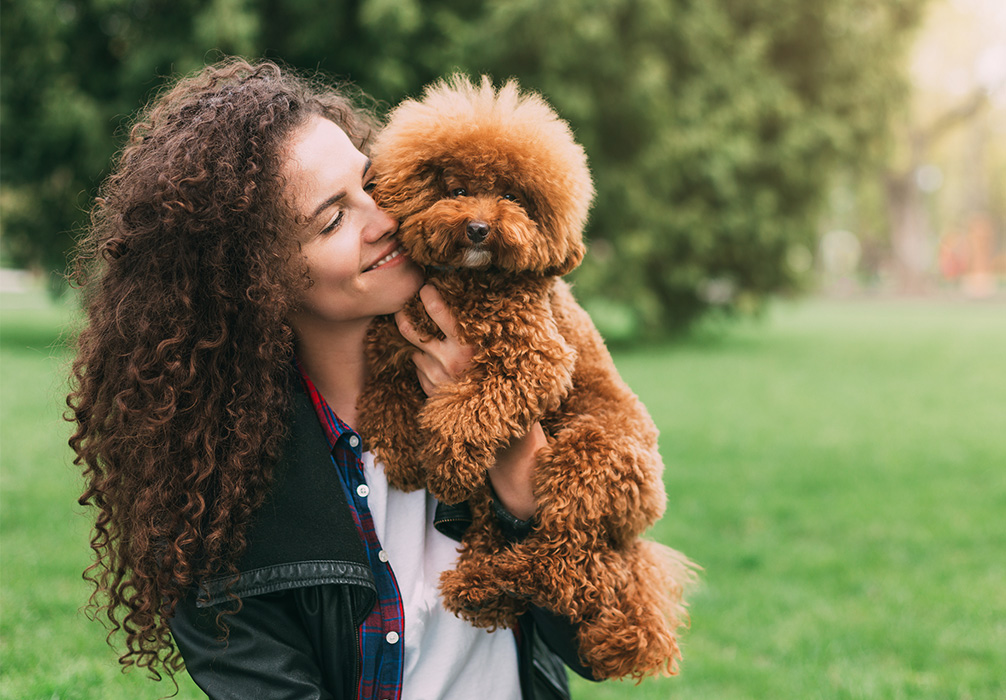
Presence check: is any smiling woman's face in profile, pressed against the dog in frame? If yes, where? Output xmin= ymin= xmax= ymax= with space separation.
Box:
xmin=283 ymin=117 xmax=423 ymax=334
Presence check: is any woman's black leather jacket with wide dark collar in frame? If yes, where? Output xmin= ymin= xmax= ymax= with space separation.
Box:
xmin=164 ymin=381 xmax=590 ymax=700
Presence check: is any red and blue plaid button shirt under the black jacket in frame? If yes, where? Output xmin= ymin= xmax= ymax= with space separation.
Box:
xmin=297 ymin=363 xmax=405 ymax=700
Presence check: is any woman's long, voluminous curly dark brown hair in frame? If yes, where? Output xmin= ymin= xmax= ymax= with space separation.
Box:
xmin=66 ymin=58 xmax=376 ymax=678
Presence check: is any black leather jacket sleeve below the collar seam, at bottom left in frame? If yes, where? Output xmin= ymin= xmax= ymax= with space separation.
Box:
xmin=169 ymin=585 xmax=357 ymax=700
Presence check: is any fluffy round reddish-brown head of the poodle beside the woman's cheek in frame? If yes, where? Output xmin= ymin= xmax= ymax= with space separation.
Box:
xmin=372 ymin=75 xmax=594 ymax=275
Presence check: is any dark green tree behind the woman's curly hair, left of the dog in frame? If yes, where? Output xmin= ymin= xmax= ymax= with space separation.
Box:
xmin=0 ymin=0 xmax=473 ymax=274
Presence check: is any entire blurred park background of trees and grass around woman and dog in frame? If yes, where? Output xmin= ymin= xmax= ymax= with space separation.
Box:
xmin=0 ymin=0 xmax=1006 ymax=700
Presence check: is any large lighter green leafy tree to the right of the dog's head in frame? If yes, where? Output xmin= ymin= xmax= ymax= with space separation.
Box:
xmin=456 ymin=0 xmax=924 ymax=333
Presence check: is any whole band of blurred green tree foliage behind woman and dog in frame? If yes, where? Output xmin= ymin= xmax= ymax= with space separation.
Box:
xmin=0 ymin=0 xmax=926 ymax=337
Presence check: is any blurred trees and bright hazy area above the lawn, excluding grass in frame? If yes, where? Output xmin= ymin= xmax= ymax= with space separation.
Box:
xmin=0 ymin=0 xmax=1006 ymax=341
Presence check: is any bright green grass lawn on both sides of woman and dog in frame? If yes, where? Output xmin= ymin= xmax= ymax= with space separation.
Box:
xmin=0 ymin=289 xmax=1006 ymax=700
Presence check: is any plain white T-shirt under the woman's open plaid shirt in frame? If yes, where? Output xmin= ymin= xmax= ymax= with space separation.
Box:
xmin=363 ymin=452 xmax=520 ymax=700
